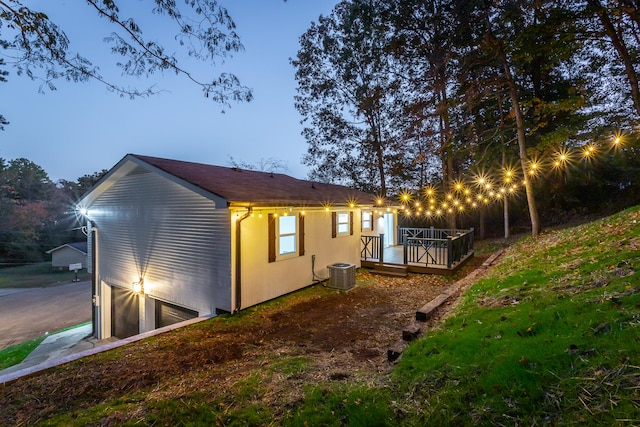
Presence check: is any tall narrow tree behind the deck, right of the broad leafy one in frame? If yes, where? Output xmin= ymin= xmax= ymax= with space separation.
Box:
xmin=392 ymin=0 xmax=464 ymax=228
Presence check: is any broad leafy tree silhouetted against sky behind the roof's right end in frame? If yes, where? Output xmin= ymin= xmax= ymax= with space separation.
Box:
xmin=291 ymin=0 xmax=404 ymax=195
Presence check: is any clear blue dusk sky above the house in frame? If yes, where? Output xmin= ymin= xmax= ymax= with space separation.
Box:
xmin=0 ymin=0 xmax=338 ymax=182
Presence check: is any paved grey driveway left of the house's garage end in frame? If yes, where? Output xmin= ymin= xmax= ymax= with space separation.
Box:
xmin=0 ymin=281 xmax=91 ymax=350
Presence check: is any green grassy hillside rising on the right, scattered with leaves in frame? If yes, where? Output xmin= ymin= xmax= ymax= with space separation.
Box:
xmin=393 ymin=208 xmax=640 ymax=425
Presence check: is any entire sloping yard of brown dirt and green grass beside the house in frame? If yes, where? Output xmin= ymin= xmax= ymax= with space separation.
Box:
xmin=0 ymin=207 xmax=640 ymax=426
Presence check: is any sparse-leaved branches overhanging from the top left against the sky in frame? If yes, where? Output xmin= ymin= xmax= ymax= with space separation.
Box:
xmin=0 ymin=0 xmax=253 ymax=126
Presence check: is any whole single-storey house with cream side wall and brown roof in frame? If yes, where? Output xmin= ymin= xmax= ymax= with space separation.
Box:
xmin=77 ymin=154 xmax=396 ymax=339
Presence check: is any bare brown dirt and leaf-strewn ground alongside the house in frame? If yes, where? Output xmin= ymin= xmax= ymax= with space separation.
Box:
xmin=0 ymin=257 xmax=486 ymax=425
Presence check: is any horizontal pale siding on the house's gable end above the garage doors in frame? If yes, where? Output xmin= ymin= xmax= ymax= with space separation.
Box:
xmin=89 ymin=168 xmax=231 ymax=320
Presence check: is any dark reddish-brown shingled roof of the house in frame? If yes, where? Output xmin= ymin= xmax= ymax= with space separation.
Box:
xmin=132 ymin=154 xmax=375 ymax=206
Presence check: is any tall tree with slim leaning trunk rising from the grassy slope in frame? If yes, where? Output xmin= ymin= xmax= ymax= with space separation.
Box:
xmin=458 ymin=0 xmax=584 ymax=236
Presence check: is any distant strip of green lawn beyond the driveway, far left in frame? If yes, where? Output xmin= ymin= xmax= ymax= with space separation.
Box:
xmin=0 ymin=262 xmax=91 ymax=288
